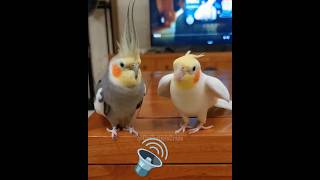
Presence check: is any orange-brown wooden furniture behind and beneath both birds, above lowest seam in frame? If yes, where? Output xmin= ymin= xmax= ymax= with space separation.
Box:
xmin=88 ymin=71 xmax=232 ymax=164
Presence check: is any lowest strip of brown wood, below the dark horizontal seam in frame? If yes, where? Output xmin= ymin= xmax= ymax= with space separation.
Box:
xmin=88 ymin=164 xmax=232 ymax=180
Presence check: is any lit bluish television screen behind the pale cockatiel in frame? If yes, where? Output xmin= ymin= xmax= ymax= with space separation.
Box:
xmin=149 ymin=0 xmax=232 ymax=46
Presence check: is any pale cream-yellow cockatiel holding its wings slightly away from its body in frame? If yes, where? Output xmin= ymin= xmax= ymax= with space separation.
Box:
xmin=158 ymin=51 xmax=232 ymax=134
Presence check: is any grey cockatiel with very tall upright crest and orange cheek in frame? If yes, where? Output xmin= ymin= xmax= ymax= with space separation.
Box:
xmin=94 ymin=0 xmax=146 ymax=139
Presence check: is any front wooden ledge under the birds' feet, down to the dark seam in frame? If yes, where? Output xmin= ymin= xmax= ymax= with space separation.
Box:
xmin=88 ymin=113 xmax=232 ymax=164
